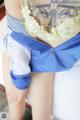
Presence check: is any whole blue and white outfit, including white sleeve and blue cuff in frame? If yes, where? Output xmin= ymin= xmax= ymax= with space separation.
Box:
xmin=5 ymin=16 xmax=80 ymax=89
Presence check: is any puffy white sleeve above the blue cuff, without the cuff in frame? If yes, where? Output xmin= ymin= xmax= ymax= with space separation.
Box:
xmin=7 ymin=36 xmax=31 ymax=75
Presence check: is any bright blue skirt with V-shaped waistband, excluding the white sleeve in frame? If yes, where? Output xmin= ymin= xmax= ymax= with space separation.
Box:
xmin=11 ymin=31 xmax=80 ymax=72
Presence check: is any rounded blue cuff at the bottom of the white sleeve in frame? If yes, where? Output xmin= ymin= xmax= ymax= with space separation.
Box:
xmin=10 ymin=71 xmax=31 ymax=90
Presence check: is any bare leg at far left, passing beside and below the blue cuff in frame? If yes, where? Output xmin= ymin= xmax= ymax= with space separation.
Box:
xmin=3 ymin=51 xmax=28 ymax=120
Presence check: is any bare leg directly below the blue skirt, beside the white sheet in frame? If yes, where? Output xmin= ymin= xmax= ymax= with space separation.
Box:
xmin=30 ymin=73 xmax=54 ymax=120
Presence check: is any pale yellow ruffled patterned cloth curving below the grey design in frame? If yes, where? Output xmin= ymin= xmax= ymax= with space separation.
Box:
xmin=22 ymin=2 xmax=80 ymax=47
